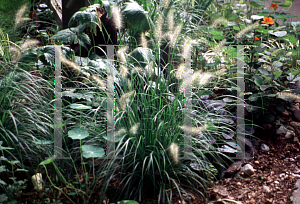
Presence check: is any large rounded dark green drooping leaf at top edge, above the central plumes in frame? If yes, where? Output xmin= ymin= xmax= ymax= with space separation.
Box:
xmin=122 ymin=0 xmax=150 ymax=32
